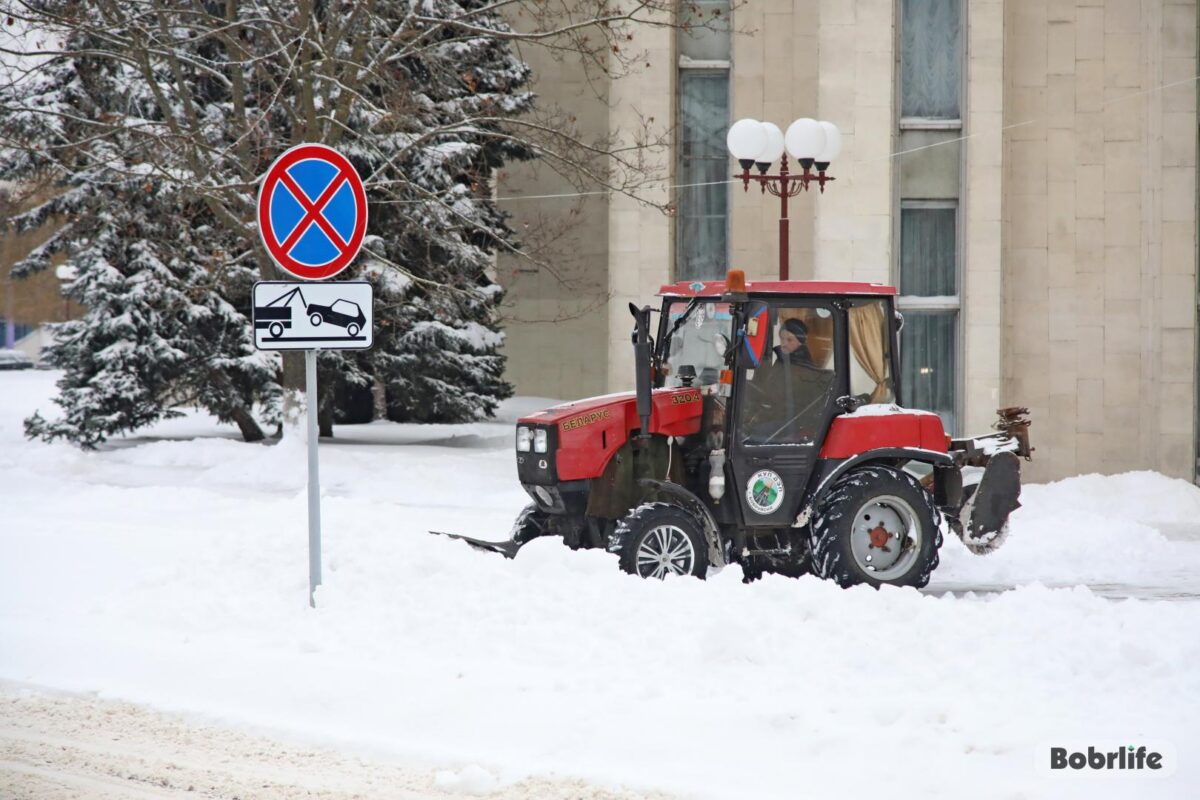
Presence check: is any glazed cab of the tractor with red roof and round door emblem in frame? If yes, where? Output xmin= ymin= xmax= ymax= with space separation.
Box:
xmin=656 ymin=277 xmax=912 ymax=537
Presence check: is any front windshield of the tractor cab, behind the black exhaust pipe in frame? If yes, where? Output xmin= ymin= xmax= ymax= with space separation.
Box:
xmin=662 ymin=301 xmax=733 ymax=387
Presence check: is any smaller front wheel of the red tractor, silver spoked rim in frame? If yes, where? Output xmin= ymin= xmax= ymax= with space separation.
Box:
xmin=608 ymin=503 xmax=708 ymax=578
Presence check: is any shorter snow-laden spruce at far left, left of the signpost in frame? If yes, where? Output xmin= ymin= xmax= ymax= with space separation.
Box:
xmin=25 ymin=182 xmax=276 ymax=447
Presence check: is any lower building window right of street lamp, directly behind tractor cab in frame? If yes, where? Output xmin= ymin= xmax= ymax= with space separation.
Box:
xmin=896 ymin=200 xmax=961 ymax=431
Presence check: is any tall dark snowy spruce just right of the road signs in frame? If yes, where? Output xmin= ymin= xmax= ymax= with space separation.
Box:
xmin=342 ymin=0 xmax=534 ymax=422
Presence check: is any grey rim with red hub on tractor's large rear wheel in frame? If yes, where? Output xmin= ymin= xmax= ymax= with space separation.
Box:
xmin=850 ymin=494 xmax=924 ymax=581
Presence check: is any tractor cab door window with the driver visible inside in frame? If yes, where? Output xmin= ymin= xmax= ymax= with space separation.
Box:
xmin=739 ymin=305 xmax=836 ymax=445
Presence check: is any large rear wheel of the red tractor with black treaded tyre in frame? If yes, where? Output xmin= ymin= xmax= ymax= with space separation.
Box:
xmin=809 ymin=465 xmax=942 ymax=589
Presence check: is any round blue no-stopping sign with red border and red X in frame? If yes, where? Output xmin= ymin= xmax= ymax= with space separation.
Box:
xmin=258 ymin=144 xmax=367 ymax=281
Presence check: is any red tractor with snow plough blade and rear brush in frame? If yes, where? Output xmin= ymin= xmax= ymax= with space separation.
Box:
xmin=441 ymin=270 xmax=1031 ymax=587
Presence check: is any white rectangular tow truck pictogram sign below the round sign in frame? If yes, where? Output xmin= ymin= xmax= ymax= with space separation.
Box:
xmin=253 ymin=281 xmax=373 ymax=350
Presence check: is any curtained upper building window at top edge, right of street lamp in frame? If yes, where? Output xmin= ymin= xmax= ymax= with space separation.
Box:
xmin=900 ymin=0 xmax=962 ymax=120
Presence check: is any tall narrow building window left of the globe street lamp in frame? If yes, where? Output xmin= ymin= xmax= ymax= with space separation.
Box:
xmin=676 ymin=0 xmax=731 ymax=281
